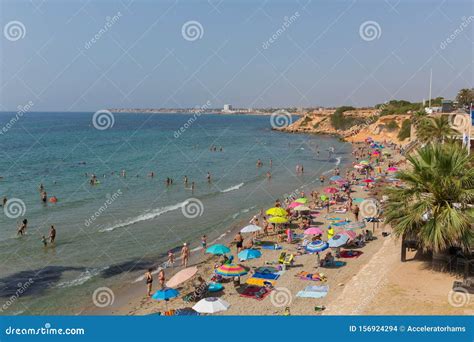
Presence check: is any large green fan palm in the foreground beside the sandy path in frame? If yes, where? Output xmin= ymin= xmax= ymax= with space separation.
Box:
xmin=384 ymin=144 xmax=474 ymax=252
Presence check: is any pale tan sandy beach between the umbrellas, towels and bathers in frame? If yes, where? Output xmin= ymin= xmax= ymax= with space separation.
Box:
xmin=85 ymin=143 xmax=473 ymax=315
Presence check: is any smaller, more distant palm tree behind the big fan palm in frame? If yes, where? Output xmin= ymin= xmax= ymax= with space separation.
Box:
xmin=416 ymin=115 xmax=459 ymax=143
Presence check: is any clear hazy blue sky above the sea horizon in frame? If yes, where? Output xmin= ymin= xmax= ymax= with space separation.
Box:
xmin=0 ymin=0 xmax=474 ymax=111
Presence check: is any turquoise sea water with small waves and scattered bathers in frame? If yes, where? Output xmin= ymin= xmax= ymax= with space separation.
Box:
xmin=0 ymin=113 xmax=350 ymax=314
